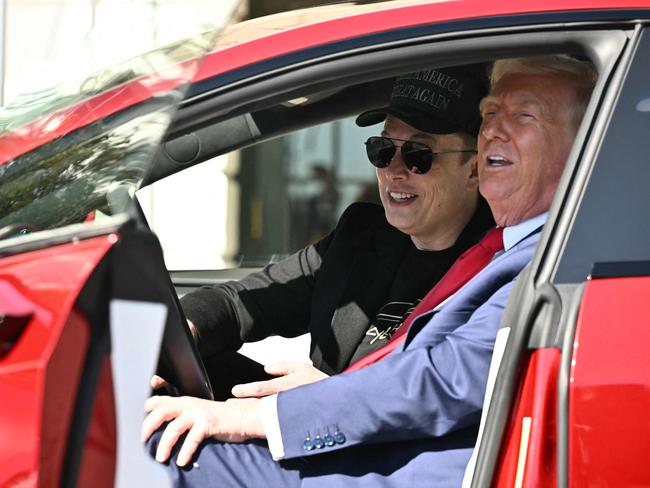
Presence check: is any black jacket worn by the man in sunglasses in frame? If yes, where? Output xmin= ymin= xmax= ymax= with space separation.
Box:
xmin=181 ymin=201 xmax=493 ymax=374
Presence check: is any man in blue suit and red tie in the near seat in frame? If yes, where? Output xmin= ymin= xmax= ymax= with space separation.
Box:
xmin=142 ymin=56 xmax=596 ymax=487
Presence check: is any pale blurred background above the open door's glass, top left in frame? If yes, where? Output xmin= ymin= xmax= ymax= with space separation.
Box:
xmin=0 ymin=0 xmax=334 ymax=105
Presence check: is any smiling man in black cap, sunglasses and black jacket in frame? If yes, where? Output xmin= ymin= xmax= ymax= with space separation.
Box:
xmin=181 ymin=65 xmax=493 ymax=397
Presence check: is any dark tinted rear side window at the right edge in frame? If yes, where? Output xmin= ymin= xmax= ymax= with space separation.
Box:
xmin=555 ymin=31 xmax=650 ymax=283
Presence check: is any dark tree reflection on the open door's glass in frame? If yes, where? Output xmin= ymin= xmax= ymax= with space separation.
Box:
xmin=0 ymin=105 xmax=171 ymax=233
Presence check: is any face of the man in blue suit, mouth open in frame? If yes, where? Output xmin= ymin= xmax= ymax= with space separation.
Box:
xmin=478 ymin=73 xmax=577 ymax=226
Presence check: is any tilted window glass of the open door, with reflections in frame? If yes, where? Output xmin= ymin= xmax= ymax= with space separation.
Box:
xmin=0 ymin=32 xmax=214 ymax=239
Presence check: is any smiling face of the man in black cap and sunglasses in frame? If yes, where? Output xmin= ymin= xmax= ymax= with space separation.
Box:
xmin=377 ymin=116 xmax=478 ymax=250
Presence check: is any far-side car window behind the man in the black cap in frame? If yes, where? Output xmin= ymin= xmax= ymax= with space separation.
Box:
xmin=138 ymin=117 xmax=381 ymax=270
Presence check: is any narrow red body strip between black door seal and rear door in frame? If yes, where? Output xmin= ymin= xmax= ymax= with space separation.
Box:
xmin=494 ymin=348 xmax=561 ymax=488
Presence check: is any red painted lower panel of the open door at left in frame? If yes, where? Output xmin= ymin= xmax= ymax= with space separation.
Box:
xmin=0 ymin=234 xmax=117 ymax=486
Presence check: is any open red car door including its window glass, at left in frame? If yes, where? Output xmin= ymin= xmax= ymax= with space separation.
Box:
xmin=0 ymin=36 xmax=210 ymax=486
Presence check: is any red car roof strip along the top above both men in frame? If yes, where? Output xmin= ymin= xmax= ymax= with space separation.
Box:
xmin=194 ymin=0 xmax=650 ymax=82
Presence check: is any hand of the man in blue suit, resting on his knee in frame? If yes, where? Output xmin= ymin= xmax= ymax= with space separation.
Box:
xmin=141 ymin=396 xmax=266 ymax=466
